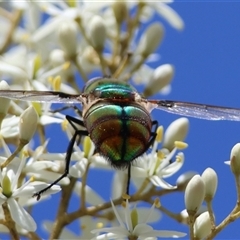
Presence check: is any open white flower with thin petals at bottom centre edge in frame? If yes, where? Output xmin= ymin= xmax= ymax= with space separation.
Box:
xmin=91 ymin=200 xmax=186 ymax=240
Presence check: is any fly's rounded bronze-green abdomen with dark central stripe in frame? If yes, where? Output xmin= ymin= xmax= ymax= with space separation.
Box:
xmin=84 ymin=103 xmax=152 ymax=168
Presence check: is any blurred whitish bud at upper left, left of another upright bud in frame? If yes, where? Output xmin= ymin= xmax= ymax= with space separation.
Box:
xmin=58 ymin=21 xmax=77 ymax=58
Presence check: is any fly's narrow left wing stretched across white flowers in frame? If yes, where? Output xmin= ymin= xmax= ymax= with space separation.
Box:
xmin=0 ymin=90 xmax=81 ymax=103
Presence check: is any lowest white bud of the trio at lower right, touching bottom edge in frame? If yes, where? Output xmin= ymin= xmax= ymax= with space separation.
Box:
xmin=193 ymin=212 xmax=211 ymax=239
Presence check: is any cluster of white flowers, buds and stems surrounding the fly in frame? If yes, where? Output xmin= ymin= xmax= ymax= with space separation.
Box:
xmin=0 ymin=0 xmax=236 ymax=239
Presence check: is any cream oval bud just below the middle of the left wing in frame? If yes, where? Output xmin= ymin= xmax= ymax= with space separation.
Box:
xmin=19 ymin=106 xmax=38 ymax=144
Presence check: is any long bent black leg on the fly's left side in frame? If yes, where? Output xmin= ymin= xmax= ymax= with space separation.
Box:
xmin=33 ymin=115 xmax=88 ymax=200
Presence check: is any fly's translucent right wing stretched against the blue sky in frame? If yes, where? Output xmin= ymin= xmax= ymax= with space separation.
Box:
xmin=148 ymin=100 xmax=240 ymax=121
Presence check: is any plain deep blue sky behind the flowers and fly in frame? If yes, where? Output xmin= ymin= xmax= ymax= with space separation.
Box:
xmin=17 ymin=1 xmax=240 ymax=239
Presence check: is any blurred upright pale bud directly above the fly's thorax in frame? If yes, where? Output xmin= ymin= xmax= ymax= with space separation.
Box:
xmin=89 ymin=15 xmax=106 ymax=52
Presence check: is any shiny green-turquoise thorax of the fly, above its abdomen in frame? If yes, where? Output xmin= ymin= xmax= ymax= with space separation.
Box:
xmin=83 ymin=78 xmax=136 ymax=101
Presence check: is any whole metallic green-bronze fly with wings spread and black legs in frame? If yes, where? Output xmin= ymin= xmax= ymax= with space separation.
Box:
xmin=0 ymin=78 xmax=240 ymax=199
